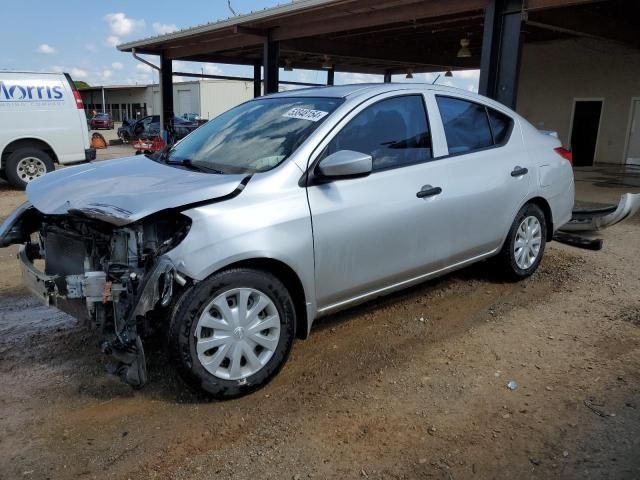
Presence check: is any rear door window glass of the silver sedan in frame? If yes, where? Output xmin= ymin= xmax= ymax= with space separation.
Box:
xmin=436 ymin=96 xmax=513 ymax=155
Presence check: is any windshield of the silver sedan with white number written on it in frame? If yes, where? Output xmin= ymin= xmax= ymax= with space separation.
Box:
xmin=164 ymin=98 xmax=342 ymax=174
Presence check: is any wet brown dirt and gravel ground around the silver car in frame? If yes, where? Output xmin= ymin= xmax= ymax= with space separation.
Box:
xmin=0 ymin=166 xmax=640 ymax=480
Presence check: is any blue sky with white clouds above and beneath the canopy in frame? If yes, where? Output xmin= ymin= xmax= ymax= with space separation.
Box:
xmin=0 ymin=0 xmax=478 ymax=91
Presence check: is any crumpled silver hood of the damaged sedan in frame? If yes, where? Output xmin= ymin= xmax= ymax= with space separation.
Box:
xmin=27 ymin=155 xmax=247 ymax=225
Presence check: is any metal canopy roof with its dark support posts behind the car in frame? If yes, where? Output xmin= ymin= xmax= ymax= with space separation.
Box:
xmin=118 ymin=0 xmax=640 ymax=134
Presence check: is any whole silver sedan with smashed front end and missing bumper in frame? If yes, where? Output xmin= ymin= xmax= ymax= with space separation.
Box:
xmin=0 ymin=84 xmax=574 ymax=399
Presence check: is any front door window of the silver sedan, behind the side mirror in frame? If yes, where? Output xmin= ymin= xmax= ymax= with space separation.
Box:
xmin=321 ymin=95 xmax=432 ymax=171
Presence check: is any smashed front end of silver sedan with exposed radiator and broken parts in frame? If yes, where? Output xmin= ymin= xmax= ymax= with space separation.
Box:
xmin=0 ymin=203 xmax=191 ymax=387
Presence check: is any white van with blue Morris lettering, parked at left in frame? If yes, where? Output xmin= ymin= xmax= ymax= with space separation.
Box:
xmin=0 ymin=71 xmax=96 ymax=188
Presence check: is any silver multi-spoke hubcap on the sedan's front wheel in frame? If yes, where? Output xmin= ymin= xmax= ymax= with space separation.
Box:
xmin=195 ymin=288 xmax=280 ymax=380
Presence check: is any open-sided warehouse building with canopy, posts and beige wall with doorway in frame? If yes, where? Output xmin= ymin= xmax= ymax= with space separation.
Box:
xmin=118 ymin=0 xmax=640 ymax=166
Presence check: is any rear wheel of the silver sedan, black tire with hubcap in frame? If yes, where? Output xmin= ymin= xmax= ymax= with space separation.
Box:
xmin=497 ymin=203 xmax=547 ymax=281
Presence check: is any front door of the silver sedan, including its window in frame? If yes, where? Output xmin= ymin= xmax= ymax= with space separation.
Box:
xmin=307 ymin=93 xmax=462 ymax=311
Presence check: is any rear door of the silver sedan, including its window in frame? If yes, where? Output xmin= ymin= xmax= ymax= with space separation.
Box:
xmin=433 ymin=94 xmax=535 ymax=262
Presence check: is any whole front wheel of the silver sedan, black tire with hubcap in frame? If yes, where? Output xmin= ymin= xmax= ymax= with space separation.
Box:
xmin=168 ymin=268 xmax=296 ymax=400
